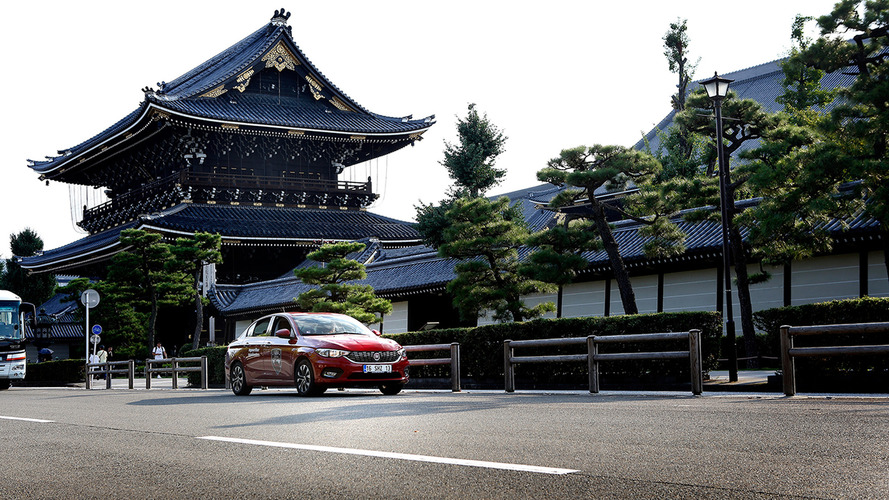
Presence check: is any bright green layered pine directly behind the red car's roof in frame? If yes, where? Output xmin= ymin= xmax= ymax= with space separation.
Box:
xmin=294 ymin=242 xmax=392 ymax=324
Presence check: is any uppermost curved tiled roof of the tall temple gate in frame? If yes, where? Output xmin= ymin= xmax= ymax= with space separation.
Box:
xmin=29 ymin=8 xmax=435 ymax=174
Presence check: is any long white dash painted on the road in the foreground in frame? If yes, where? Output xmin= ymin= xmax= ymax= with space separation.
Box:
xmin=198 ymin=436 xmax=580 ymax=474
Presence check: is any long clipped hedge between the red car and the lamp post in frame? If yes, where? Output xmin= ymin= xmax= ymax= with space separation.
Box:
xmin=386 ymin=312 xmax=722 ymax=388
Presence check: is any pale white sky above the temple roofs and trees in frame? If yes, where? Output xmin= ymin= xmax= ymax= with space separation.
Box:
xmin=0 ymin=0 xmax=835 ymax=258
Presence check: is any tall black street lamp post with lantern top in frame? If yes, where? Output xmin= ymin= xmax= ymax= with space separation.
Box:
xmin=701 ymin=72 xmax=738 ymax=382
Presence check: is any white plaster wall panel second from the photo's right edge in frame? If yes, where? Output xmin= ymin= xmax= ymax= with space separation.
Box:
xmin=791 ymin=254 xmax=860 ymax=306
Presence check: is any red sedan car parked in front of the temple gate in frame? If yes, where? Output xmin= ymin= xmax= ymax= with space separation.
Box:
xmin=225 ymin=313 xmax=408 ymax=396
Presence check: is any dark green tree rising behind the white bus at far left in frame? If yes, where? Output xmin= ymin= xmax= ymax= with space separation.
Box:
xmin=0 ymin=228 xmax=56 ymax=306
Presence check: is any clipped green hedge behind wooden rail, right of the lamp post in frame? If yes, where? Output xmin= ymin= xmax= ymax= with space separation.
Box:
xmin=753 ymin=297 xmax=889 ymax=391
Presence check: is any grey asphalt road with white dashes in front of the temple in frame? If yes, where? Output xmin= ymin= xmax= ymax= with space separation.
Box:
xmin=0 ymin=387 xmax=889 ymax=499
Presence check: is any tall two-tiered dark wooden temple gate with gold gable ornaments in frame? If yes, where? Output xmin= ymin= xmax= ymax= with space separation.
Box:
xmin=21 ymin=9 xmax=435 ymax=283
